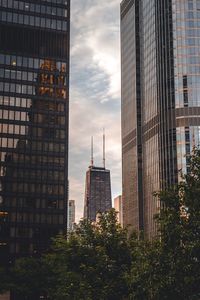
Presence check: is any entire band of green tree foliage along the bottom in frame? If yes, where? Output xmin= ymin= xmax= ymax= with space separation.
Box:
xmin=3 ymin=149 xmax=200 ymax=300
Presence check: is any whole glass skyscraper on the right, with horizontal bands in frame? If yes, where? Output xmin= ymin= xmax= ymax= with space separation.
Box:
xmin=121 ymin=0 xmax=200 ymax=237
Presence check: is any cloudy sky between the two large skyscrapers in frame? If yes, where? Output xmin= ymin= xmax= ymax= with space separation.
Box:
xmin=69 ymin=0 xmax=121 ymax=222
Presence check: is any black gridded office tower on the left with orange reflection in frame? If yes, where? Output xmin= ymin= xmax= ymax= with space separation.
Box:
xmin=0 ymin=0 xmax=70 ymax=261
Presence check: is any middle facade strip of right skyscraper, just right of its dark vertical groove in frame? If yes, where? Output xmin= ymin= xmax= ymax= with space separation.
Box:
xmin=140 ymin=0 xmax=160 ymax=236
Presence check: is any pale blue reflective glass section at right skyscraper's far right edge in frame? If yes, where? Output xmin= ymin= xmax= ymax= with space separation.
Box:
xmin=172 ymin=0 xmax=200 ymax=177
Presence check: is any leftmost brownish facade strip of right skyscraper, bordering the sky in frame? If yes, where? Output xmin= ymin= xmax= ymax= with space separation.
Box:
xmin=121 ymin=0 xmax=140 ymax=229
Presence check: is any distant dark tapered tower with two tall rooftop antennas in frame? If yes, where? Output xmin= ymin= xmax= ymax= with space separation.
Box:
xmin=84 ymin=135 xmax=112 ymax=221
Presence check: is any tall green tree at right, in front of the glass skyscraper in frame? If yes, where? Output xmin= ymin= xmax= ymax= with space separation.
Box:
xmin=129 ymin=149 xmax=200 ymax=300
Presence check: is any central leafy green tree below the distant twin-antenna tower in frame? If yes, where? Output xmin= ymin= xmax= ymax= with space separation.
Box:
xmin=44 ymin=210 xmax=131 ymax=300
